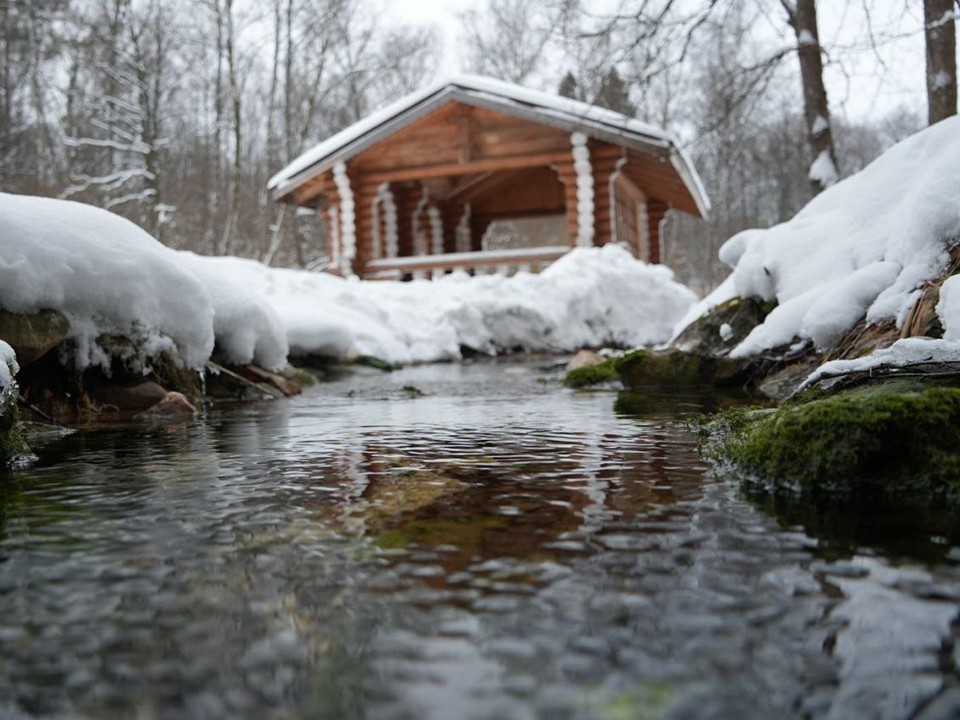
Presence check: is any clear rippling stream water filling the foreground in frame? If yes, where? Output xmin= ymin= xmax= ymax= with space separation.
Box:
xmin=0 ymin=361 xmax=960 ymax=720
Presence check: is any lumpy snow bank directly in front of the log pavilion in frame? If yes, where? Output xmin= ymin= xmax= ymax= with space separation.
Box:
xmin=204 ymin=246 xmax=696 ymax=363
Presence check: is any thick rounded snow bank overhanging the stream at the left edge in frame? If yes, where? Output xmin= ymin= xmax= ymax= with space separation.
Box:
xmin=0 ymin=193 xmax=286 ymax=368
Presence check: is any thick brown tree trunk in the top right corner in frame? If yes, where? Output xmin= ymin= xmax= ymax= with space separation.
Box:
xmin=923 ymin=0 xmax=960 ymax=125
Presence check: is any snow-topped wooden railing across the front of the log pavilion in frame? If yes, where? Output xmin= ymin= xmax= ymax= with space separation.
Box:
xmin=364 ymin=245 xmax=570 ymax=280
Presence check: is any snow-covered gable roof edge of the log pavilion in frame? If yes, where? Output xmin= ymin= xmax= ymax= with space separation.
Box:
xmin=267 ymin=75 xmax=710 ymax=215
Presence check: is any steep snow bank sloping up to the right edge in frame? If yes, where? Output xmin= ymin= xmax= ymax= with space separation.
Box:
xmin=688 ymin=117 xmax=960 ymax=357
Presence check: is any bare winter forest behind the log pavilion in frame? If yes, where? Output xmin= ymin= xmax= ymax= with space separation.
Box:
xmin=0 ymin=0 xmax=960 ymax=293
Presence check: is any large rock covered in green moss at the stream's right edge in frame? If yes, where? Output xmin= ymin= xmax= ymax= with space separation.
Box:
xmin=712 ymin=380 xmax=960 ymax=499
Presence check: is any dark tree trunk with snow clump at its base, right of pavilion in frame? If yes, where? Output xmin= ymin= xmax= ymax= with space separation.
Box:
xmin=780 ymin=0 xmax=839 ymax=193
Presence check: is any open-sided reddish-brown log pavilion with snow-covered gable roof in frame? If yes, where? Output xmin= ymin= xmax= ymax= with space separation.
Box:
xmin=269 ymin=76 xmax=709 ymax=278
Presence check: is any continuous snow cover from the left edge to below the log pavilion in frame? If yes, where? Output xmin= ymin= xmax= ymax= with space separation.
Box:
xmin=0 ymin=193 xmax=696 ymax=368
